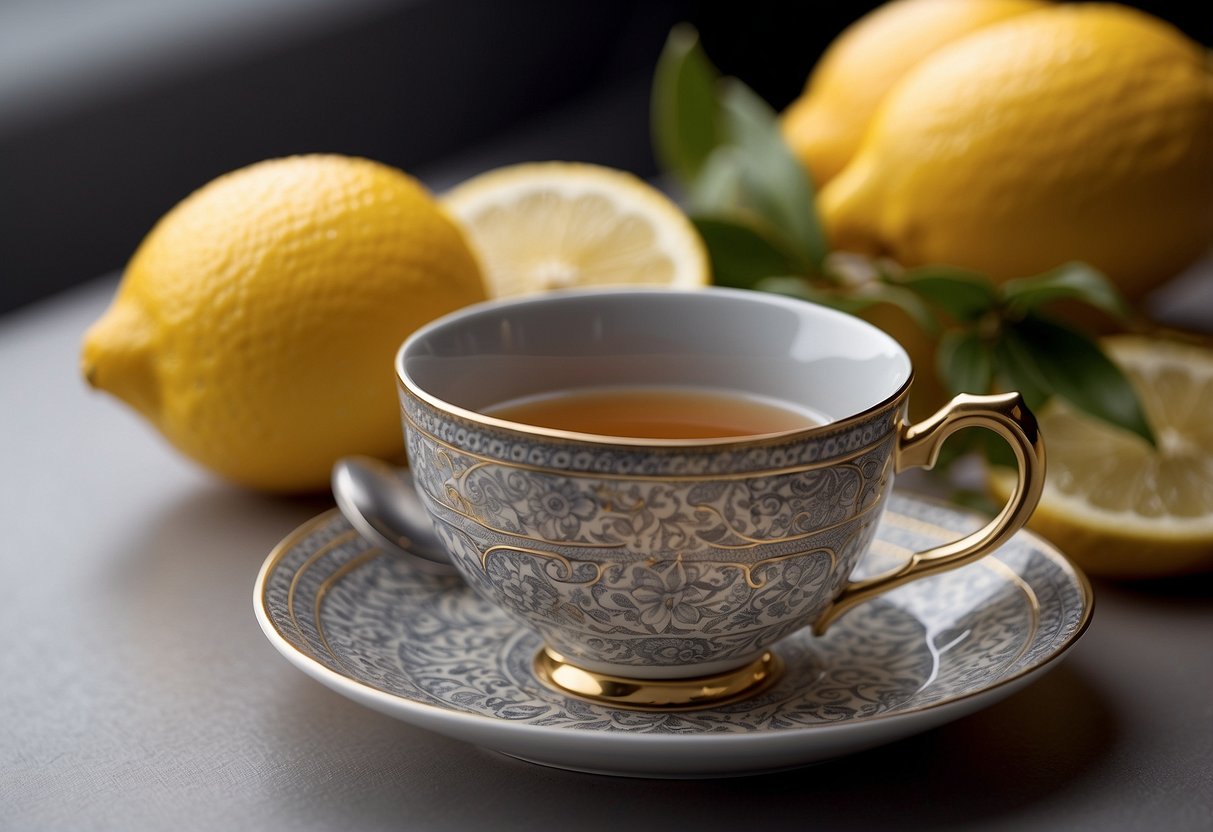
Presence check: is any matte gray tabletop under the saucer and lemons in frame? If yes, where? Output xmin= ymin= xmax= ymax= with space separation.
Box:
xmin=0 ymin=280 xmax=1213 ymax=832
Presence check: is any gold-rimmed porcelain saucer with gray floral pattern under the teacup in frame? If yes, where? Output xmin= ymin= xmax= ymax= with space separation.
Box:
xmin=254 ymin=494 xmax=1093 ymax=777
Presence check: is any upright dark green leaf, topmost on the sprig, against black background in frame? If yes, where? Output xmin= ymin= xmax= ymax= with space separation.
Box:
xmin=649 ymin=23 xmax=719 ymax=184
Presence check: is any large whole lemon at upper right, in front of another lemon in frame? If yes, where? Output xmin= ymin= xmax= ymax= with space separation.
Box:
xmin=819 ymin=4 xmax=1213 ymax=298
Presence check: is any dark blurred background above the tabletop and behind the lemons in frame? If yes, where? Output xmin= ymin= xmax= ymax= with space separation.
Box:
xmin=0 ymin=0 xmax=1213 ymax=310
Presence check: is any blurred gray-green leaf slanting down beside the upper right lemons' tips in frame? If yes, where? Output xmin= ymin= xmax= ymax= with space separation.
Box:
xmin=719 ymin=79 xmax=828 ymax=270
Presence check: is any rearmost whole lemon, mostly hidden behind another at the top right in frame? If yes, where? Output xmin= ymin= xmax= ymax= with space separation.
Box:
xmin=780 ymin=0 xmax=1044 ymax=187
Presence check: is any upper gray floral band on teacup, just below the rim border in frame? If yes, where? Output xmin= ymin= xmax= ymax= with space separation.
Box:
xmin=409 ymin=431 xmax=893 ymax=552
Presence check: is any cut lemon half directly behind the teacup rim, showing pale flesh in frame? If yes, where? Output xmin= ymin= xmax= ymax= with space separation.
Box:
xmin=443 ymin=161 xmax=711 ymax=297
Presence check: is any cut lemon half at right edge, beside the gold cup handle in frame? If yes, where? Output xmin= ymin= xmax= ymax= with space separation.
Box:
xmin=991 ymin=336 xmax=1213 ymax=577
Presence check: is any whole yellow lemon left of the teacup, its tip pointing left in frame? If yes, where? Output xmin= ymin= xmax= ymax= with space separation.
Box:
xmin=81 ymin=155 xmax=485 ymax=491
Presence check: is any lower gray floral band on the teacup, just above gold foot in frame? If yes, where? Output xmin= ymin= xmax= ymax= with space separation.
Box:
xmin=417 ymin=494 xmax=875 ymax=666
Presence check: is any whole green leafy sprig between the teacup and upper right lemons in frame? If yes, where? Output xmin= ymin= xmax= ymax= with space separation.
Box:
xmin=651 ymin=24 xmax=1155 ymax=444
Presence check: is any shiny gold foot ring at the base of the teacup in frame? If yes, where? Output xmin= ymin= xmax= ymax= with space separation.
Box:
xmin=534 ymin=648 xmax=784 ymax=711
